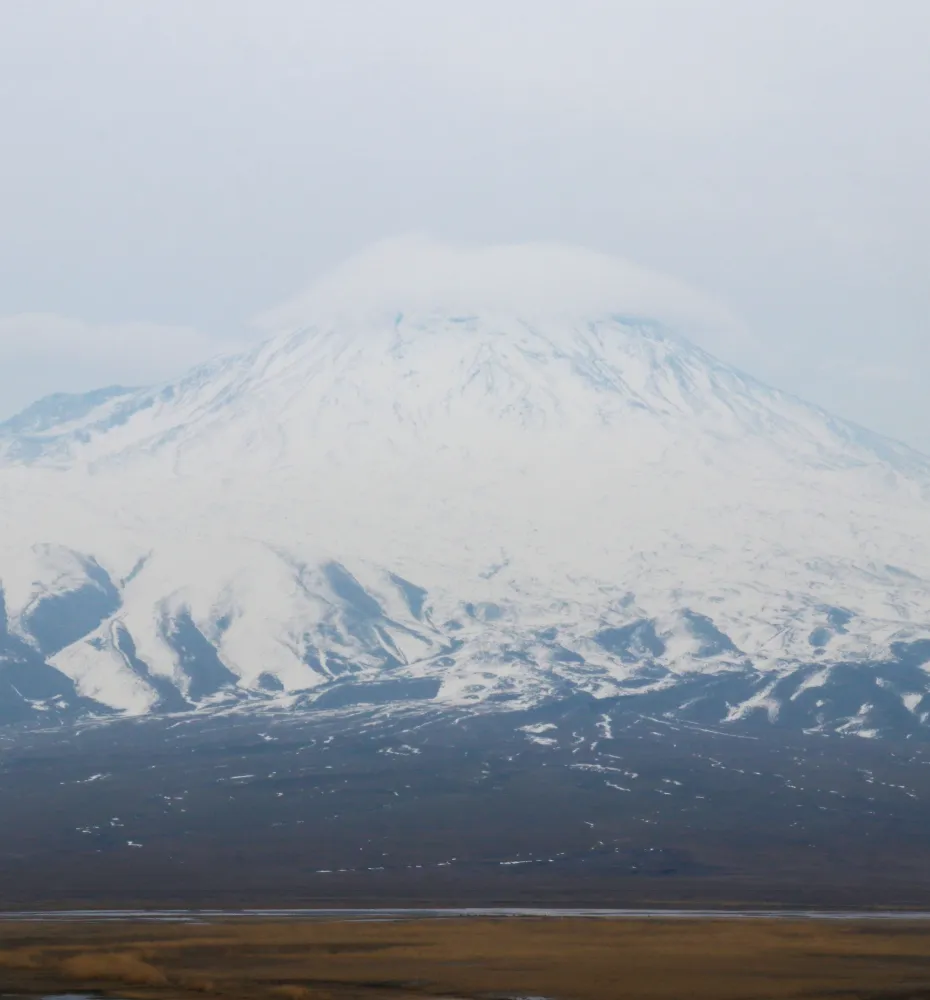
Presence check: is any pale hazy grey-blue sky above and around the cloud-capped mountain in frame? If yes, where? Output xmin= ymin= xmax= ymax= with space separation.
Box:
xmin=0 ymin=0 xmax=930 ymax=451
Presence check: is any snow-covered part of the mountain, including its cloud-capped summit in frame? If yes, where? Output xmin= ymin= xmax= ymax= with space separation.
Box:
xmin=0 ymin=241 xmax=930 ymax=735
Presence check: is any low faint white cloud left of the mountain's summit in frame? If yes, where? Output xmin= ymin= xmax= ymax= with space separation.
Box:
xmin=0 ymin=313 xmax=242 ymax=416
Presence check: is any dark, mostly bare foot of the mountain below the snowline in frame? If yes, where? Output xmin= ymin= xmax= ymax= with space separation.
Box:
xmin=0 ymin=703 xmax=930 ymax=911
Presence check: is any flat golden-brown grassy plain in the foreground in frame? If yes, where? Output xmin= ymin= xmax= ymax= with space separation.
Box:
xmin=0 ymin=918 xmax=930 ymax=1000
